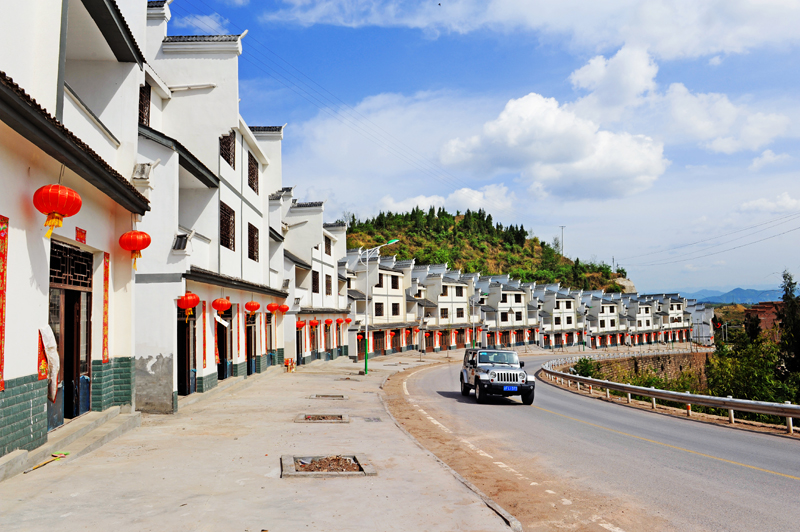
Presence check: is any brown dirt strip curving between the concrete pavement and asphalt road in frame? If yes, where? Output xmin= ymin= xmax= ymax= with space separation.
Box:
xmin=384 ymin=368 xmax=670 ymax=532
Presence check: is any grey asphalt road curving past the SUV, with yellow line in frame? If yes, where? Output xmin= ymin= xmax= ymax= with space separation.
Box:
xmin=408 ymin=354 xmax=800 ymax=531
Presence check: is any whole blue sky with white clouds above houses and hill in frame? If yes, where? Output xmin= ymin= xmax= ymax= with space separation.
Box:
xmin=164 ymin=0 xmax=800 ymax=292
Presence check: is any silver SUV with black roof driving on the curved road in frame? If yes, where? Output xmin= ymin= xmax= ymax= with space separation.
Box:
xmin=460 ymin=349 xmax=536 ymax=405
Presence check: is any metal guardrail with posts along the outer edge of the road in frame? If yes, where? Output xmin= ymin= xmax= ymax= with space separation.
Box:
xmin=542 ymin=350 xmax=800 ymax=434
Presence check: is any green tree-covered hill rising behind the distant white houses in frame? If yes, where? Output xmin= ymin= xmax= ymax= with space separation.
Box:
xmin=341 ymin=207 xmax=626 ymax=292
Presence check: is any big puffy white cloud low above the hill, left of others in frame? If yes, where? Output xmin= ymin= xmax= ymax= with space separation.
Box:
xmin=442 ymin=93 xmax=669 ymax=199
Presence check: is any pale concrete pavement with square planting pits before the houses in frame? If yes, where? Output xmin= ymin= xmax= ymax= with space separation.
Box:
xmin=0 ymin=353 xmax=508 ymax=532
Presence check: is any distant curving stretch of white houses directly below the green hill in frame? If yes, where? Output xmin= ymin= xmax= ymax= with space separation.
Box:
xmin=339 ymin=254 xmax=713 ymax=359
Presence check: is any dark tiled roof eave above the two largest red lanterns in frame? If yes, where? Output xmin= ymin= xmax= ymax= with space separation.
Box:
xmin=0 ymin=72 xmax=150 ymax=215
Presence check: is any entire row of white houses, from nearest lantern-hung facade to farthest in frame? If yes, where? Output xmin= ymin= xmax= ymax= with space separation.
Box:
xmin=0 ymin=0 xmax=710 ymax=462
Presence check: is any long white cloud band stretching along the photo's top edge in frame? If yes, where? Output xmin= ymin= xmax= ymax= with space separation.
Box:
xmin=262 ymin=0 xmax=800 ymax=59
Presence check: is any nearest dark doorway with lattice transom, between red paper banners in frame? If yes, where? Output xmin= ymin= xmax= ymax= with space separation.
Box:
xmin=47 ymin=240 xmax=94 ymax=430
